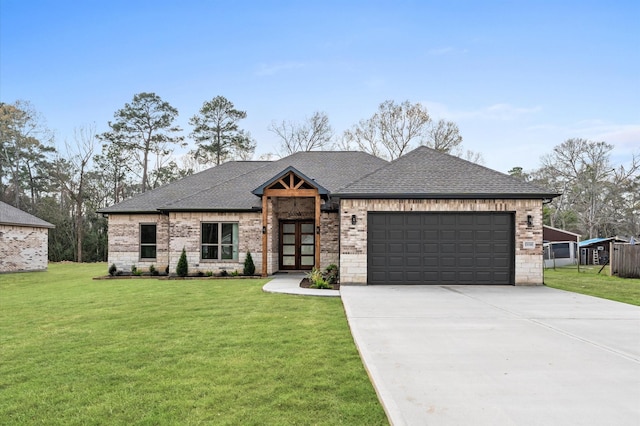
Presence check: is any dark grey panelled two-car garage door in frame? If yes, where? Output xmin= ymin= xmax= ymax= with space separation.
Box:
xmin=367 ymin=212 xmax=515 ymax=284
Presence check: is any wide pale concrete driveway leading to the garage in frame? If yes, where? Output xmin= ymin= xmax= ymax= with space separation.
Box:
xmin=340 ymin=286 xmax=640 ymax=426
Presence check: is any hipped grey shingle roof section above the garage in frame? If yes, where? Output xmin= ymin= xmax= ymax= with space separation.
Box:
xmin=337 ymin=146 xmax=557 ymax=198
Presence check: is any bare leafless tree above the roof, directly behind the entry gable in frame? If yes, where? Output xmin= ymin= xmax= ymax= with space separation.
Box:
xmin=268 ymin=111 xmax=333 ymax=156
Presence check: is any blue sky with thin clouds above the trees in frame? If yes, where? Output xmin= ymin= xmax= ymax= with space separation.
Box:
xmin=0 ymin=0 xmax=640 ymax=172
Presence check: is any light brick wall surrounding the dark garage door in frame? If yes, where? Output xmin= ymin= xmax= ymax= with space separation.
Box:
xmin=340 ymin=199 xmax=543 ymax=285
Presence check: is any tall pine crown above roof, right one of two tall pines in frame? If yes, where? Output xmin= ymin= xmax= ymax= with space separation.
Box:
xmin=189 ymin=96 xmax=256 ymax=165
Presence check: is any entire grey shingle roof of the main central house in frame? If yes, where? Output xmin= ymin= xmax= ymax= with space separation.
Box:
xmin=99 ymin=147 xmax=557 ymax=213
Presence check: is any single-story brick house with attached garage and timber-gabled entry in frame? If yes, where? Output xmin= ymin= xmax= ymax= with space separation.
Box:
xmin=100 ymin=147 xmax=557 ymax=285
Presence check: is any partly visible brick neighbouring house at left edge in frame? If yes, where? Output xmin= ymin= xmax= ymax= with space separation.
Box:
xmin=0 ymin=201 xmax=54 ymax=273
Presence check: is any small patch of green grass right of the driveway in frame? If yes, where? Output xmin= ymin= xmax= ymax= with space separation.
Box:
xmin=544 ymin=265 xmax=640 ymax=306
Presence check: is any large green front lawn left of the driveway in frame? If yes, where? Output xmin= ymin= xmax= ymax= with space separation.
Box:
xmin=0 ymin=264 xmax=388 ymax=425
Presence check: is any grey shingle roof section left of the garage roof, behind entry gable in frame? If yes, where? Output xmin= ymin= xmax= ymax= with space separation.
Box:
xmin=99 ymin=151 xmax=387 ymax=213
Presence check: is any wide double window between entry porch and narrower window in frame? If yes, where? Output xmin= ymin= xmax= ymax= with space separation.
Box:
xmin=200 ymin=222 xmax=238 ymax=260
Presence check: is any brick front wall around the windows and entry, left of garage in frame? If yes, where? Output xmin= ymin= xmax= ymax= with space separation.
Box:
xmin=108 ymin=198 xmax=339 ymax=274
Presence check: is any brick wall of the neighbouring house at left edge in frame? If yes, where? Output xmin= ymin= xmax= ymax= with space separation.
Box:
xmin=0 ymin=225 xmax=49 ymax=272
